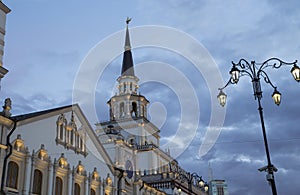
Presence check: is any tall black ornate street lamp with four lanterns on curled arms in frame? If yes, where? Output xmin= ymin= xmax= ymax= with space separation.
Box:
xmin=218 ymin=58 xmax=300 ymax=195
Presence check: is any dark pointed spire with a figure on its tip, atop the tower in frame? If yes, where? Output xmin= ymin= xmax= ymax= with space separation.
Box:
xmin=121 ymin=17 xmax=135 ymax=76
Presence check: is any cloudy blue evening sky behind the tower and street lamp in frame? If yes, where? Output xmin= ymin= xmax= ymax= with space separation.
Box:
xmin=0 ymin=0 xmax=300 ymax=195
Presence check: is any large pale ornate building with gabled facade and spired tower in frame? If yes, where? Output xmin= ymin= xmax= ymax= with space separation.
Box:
xmin=0 ymin=4 xmax=223 ymax=195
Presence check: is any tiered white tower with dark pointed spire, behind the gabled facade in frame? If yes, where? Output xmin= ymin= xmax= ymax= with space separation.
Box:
xmin=96 ymin=18 xmax=163 ymax=194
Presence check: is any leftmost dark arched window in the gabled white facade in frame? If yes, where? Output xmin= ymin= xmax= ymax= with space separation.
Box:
xmin=6 ymin=161 xmax=19 ymax=189
